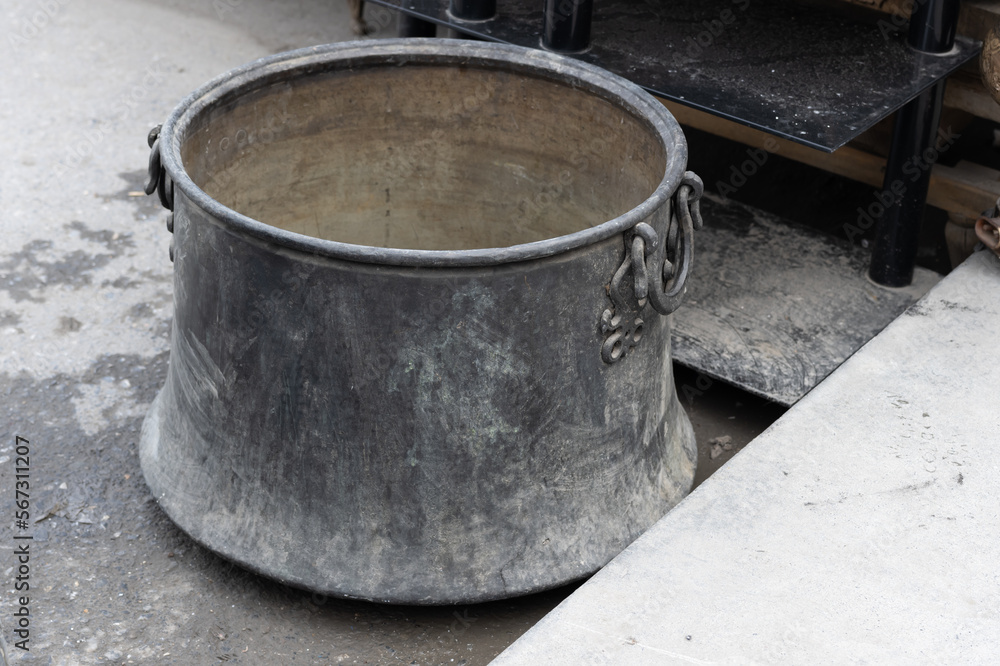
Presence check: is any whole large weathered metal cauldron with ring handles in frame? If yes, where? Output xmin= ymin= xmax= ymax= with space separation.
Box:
xmin=141 ymin=40 xmax=700 ymax=604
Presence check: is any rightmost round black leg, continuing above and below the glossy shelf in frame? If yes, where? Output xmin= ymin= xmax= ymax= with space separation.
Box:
xmin=868 ymin=0 xmax=958 ymax=287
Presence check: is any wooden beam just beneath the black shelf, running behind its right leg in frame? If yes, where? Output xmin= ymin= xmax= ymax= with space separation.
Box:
xmin=660 ymin=100 xmax=1000 ymax=217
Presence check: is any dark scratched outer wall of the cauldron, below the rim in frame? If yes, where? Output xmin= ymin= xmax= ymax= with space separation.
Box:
xmin=140 ymin=192 xmax=696 ymax=604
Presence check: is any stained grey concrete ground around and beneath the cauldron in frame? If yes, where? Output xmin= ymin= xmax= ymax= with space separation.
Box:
xmin=0 ymin=0 xmax=781 ymax=666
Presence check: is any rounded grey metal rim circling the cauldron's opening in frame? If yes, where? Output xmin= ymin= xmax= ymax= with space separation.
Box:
xmin=160 ymin=38 xmax=687 ymax=267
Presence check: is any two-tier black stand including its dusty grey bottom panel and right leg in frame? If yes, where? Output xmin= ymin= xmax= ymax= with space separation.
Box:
xmin=371 ymin=0 xmax=979 ymax=404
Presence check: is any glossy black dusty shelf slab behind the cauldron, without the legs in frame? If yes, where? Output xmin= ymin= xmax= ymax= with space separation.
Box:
xmin=369 ymin=0 xmax=979 ymax=152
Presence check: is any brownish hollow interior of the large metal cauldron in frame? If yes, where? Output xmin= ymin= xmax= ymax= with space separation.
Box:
xmin=181 ymin=55 xmax=667 ymax=250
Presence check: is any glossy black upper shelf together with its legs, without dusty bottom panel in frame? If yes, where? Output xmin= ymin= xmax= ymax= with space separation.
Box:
xmin=371 ymin=0 xmax=980 ymax=286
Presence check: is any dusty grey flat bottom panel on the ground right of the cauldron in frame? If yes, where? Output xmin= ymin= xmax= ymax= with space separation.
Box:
xmin=673 ymin=194 xmax=940 ymax=405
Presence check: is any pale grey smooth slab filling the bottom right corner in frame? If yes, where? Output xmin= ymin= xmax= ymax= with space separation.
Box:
xmin=494 ymin=252 xmax=1000 ymax=666
